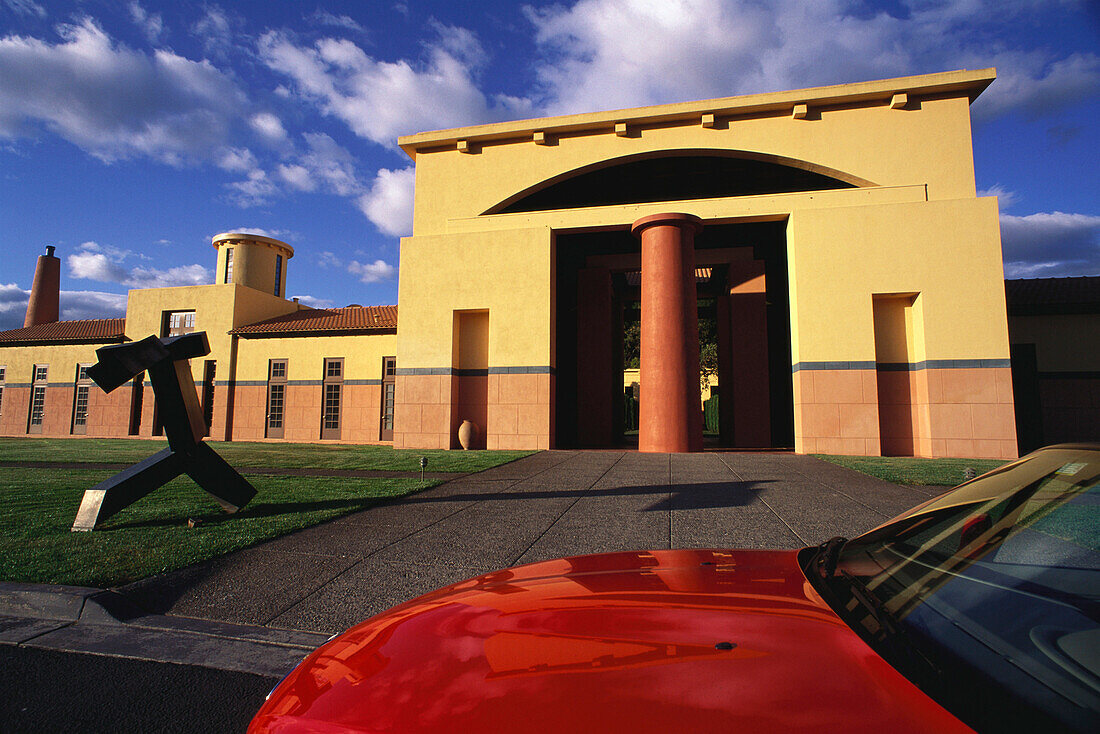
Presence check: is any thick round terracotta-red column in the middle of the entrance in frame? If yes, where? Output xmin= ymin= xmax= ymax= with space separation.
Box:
xmin=630 ymin=213 xmax=703 ymax=452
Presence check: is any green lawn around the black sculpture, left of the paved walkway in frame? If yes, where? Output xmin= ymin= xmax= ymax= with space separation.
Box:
xmin=0 ymin=439 xmax=531 ymax=587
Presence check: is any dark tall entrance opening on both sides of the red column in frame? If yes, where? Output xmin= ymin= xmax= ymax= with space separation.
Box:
xmin=554 ymin=221 xmax=794 ymax=448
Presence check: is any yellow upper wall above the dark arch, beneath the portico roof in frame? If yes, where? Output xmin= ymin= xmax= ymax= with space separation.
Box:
xmin=403 ymin=75 xmax=991 ymax=235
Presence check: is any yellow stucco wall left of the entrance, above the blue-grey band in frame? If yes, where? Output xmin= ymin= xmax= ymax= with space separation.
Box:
xmin=397 ymin=228 xmax=553 ymax=370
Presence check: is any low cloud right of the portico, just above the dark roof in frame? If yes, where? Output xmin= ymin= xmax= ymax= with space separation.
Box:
xmin=1001 ymin=211 xmax=1100 ymax=277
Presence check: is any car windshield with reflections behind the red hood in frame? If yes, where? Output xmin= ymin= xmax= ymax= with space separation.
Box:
xmin=822 ymin=448 xmax=1100 ymax=731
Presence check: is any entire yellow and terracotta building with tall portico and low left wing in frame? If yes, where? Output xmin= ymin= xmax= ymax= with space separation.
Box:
xmin=0 ymin=69 xmax=1038 ymax=458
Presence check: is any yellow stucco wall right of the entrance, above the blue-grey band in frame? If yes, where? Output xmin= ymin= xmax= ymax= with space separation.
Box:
xmin=788 ymin=198 xmax=1009 ymax=362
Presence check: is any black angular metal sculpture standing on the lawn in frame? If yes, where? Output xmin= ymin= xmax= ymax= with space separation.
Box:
xmin=73 ymin=331 xmax=256 ymax=530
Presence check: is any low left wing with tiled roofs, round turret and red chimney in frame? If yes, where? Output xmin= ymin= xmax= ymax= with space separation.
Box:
xmin=0 ymin=232 xmax=397 ymax=442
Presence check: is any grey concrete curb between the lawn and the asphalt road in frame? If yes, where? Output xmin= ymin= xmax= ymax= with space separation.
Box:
xmin=0 ymin=583 xmax=329 ymax=678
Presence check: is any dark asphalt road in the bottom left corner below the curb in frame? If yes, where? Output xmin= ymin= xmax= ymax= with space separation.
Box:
xmin=0 ymin=645 xmax=278 ymax=733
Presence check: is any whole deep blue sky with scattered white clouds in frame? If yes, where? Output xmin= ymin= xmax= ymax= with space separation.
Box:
xmin=0 ymin=0 xmax=1100 ymax=329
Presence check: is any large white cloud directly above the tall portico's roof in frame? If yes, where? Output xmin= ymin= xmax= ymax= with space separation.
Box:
xmin=526 ymin=0 xmax=1100 ymax=117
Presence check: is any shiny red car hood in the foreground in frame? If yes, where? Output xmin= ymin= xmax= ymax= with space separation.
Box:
xmin=250 ymin=550 xmax=970 ymax=733
